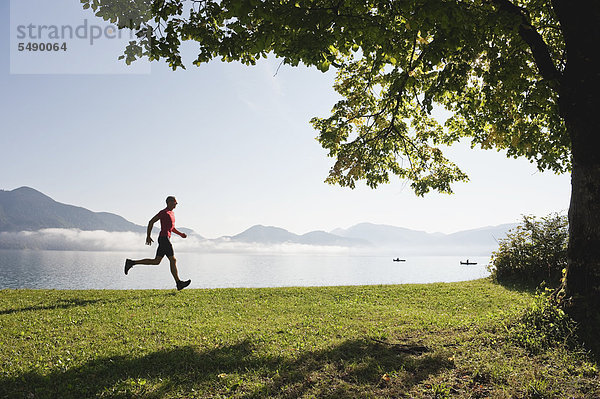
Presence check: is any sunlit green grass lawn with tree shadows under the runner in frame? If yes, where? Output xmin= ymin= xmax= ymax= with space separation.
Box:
xmin=0 ymin=280 xmax=600 ymax=399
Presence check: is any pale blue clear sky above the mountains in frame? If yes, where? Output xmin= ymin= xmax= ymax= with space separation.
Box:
xmin=0 ymin=0 xmax=570 ymax=238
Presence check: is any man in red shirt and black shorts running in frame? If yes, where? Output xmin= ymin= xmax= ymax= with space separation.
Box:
xmin=125 ymin=196 xmax=192 ymax=290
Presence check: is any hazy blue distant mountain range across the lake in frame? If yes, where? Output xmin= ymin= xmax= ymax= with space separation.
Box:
xmin=0 ymin=187 xmax=517 ymax=253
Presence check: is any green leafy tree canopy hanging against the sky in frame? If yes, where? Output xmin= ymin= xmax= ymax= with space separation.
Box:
xmin=81 ymin=0 xmax=570 ymax=195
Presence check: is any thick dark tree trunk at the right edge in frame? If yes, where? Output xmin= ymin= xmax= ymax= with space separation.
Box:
xmin=553 ymin=0 xmax=600 ymax=338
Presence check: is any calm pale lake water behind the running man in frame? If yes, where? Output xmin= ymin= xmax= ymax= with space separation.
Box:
xmin=0 ymin=250 xmax=490 ymax=289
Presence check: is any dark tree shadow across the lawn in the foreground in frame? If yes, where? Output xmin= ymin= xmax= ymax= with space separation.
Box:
xmin=0 ymin=340 xmax=454 ymax=399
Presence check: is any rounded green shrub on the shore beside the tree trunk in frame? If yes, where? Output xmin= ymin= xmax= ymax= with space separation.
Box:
xmin=488 ymin=213 xmax=569 ymax=287
